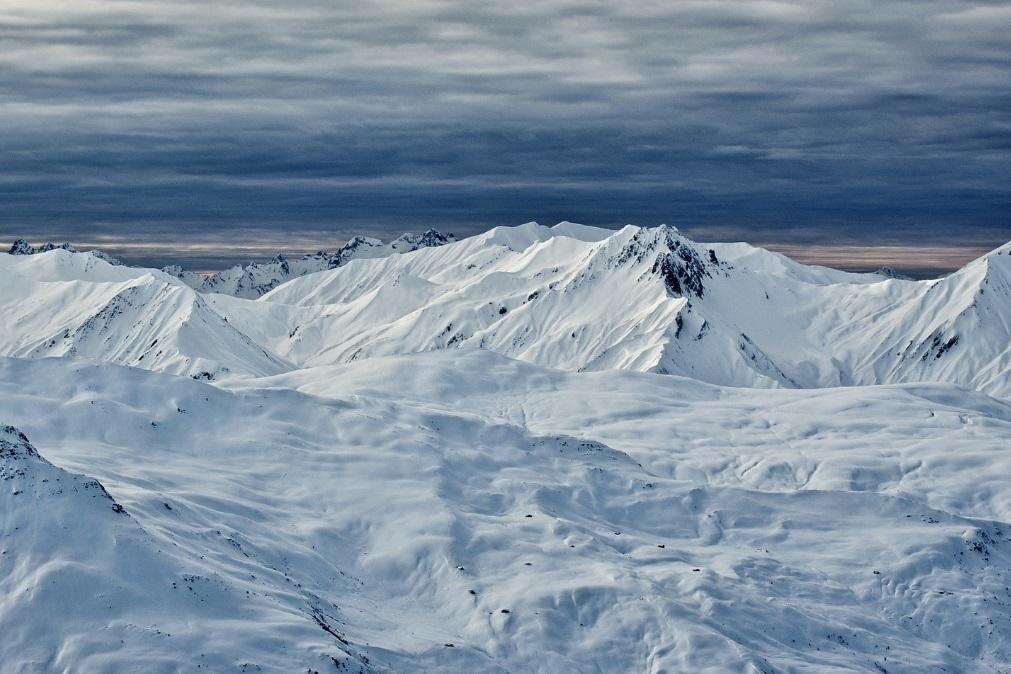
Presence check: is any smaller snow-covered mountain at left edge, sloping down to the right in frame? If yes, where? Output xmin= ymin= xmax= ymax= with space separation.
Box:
xmin=0 ymin=250 xmax=290 ymax=377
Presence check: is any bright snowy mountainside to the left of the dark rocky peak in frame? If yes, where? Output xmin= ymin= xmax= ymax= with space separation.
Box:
xmin=227 ymin=223 xmax=684 ymax=370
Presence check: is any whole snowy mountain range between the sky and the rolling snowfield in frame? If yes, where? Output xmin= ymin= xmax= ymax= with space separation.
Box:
xmin=0 ymin=223 xmax=1011 ymax=396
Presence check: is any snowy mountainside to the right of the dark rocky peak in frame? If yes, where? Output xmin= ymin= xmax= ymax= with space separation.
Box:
xmin=671 ymin=239 xmax=1011 ymax=396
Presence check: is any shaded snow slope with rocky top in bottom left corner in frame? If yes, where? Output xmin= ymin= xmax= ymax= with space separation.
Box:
xmin=0 ymin=426 xmax=363 ymax=672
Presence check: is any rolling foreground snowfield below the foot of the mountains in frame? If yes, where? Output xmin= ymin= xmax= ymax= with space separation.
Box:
xmin=0 ymin=352 xmax=1011 ymax=673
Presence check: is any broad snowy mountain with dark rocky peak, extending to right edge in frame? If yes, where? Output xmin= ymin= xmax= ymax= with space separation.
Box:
xmin=246 ymin=223 xmax=1011 ymax=396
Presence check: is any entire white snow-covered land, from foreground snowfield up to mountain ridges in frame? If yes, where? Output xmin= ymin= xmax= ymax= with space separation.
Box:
xmin=0 ymin=223 xmax=1011 ymax=674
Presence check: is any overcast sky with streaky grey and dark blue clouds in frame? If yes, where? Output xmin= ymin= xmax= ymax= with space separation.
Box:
xmin=0 ymin=0 xmax=1011 ymax=268
